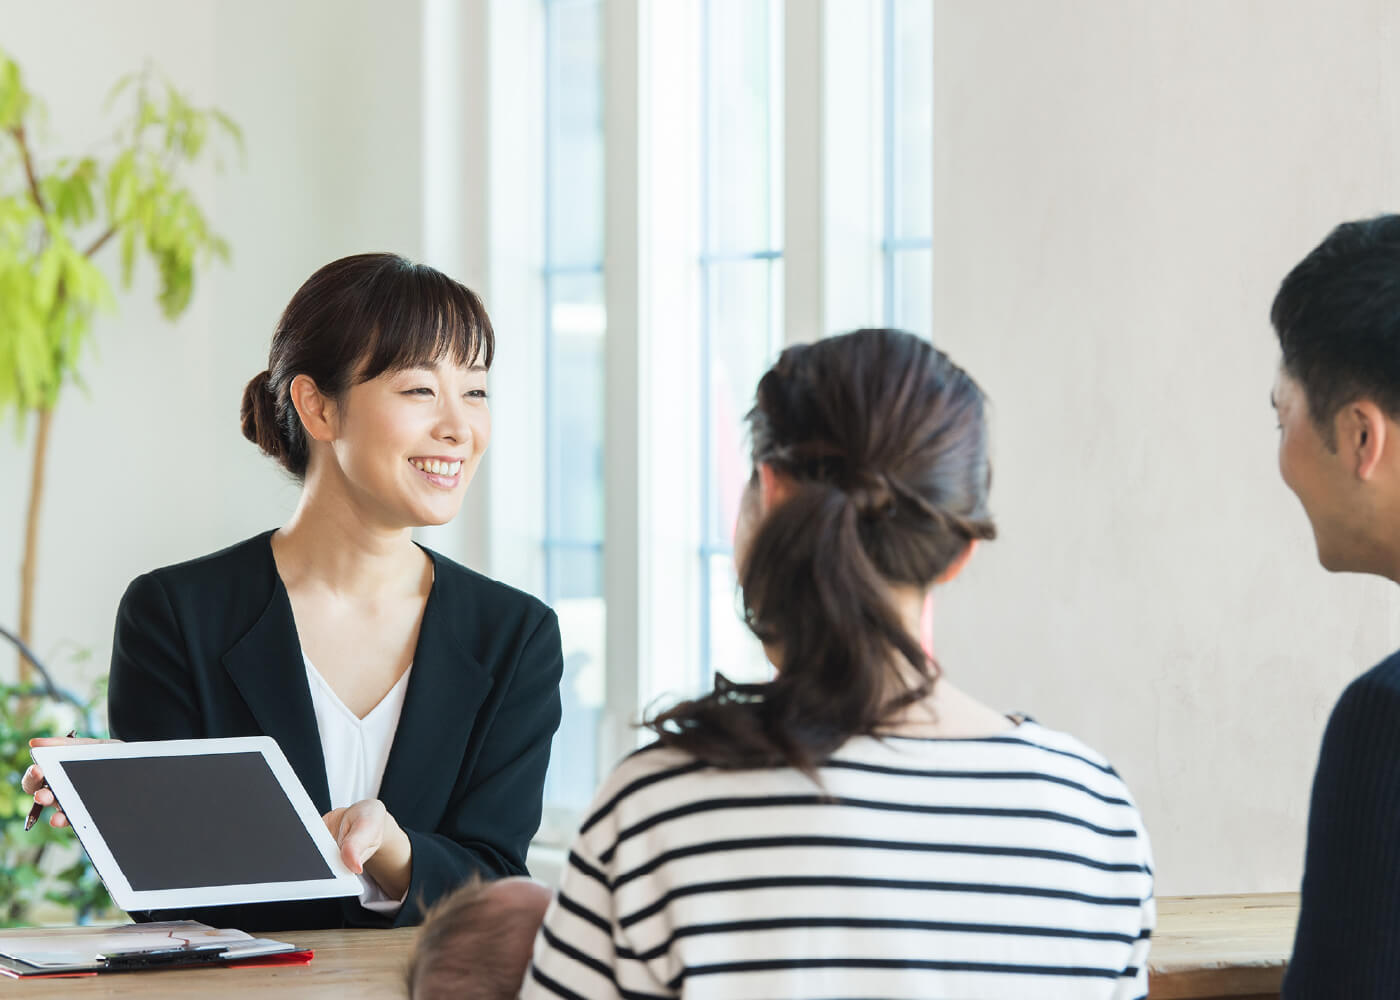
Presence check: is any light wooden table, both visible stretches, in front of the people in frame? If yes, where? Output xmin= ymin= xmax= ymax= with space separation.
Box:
xmin=0 ymin=892 xmax=1298 ymax=1000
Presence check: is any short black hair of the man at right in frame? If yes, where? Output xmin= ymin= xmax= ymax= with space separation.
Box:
xmin=1270 ymin=216 xmax=1400 ymax=445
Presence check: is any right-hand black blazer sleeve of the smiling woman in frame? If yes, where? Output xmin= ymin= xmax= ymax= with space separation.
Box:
xmin=393 ymin=609 xmax=564 ymax=927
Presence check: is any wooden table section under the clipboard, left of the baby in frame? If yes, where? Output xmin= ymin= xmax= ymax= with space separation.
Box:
xmin=0 ymin=927 xmax=414 ymax=1000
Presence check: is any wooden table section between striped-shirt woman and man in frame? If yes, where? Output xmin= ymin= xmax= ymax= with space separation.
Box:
xmin=1148 ymin=892 xmax=1298 ymax=1000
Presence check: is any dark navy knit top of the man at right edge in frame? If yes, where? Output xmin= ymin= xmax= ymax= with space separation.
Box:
xmin=1282 ymin=661 xmax=1400 ymax=1000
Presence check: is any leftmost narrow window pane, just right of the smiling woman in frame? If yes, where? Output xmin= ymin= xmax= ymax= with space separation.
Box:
xmin=540 ymin=0 xmax=606 ymax=811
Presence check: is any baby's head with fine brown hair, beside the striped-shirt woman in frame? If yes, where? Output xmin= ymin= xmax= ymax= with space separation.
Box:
xmin=407 ymin=877 xmax=542 ymax=1000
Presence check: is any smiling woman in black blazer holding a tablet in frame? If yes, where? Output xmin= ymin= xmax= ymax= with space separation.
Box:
xmin=25 ymin=254 xmax=563 ymax=930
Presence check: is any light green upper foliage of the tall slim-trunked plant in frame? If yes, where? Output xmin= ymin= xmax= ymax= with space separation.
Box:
xmin=0 ymin=50 xmax=242 ymax=422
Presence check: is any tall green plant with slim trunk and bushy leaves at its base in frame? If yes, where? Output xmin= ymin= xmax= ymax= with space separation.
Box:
xmin=0 ymin=50 xmax=242 ymax=926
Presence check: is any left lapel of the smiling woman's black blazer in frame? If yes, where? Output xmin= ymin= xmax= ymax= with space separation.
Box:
xmin=224 ymin=579 xmax=330 ymax=814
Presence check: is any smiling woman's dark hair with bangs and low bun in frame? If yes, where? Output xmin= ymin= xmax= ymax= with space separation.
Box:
xmin=239 ymin=254 xmax=496 ymax=479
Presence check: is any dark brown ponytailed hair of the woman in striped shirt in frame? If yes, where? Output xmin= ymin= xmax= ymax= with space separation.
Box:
xmin=647 ymin=329 xmax=995 ymax=772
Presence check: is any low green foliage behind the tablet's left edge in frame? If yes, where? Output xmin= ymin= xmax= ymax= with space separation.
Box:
xmin=0 ymin=681 xmax=118 ymax=927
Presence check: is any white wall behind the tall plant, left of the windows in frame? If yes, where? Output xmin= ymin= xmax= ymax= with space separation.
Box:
xmin=0 ymin=0 xmax=436 ymax=697
